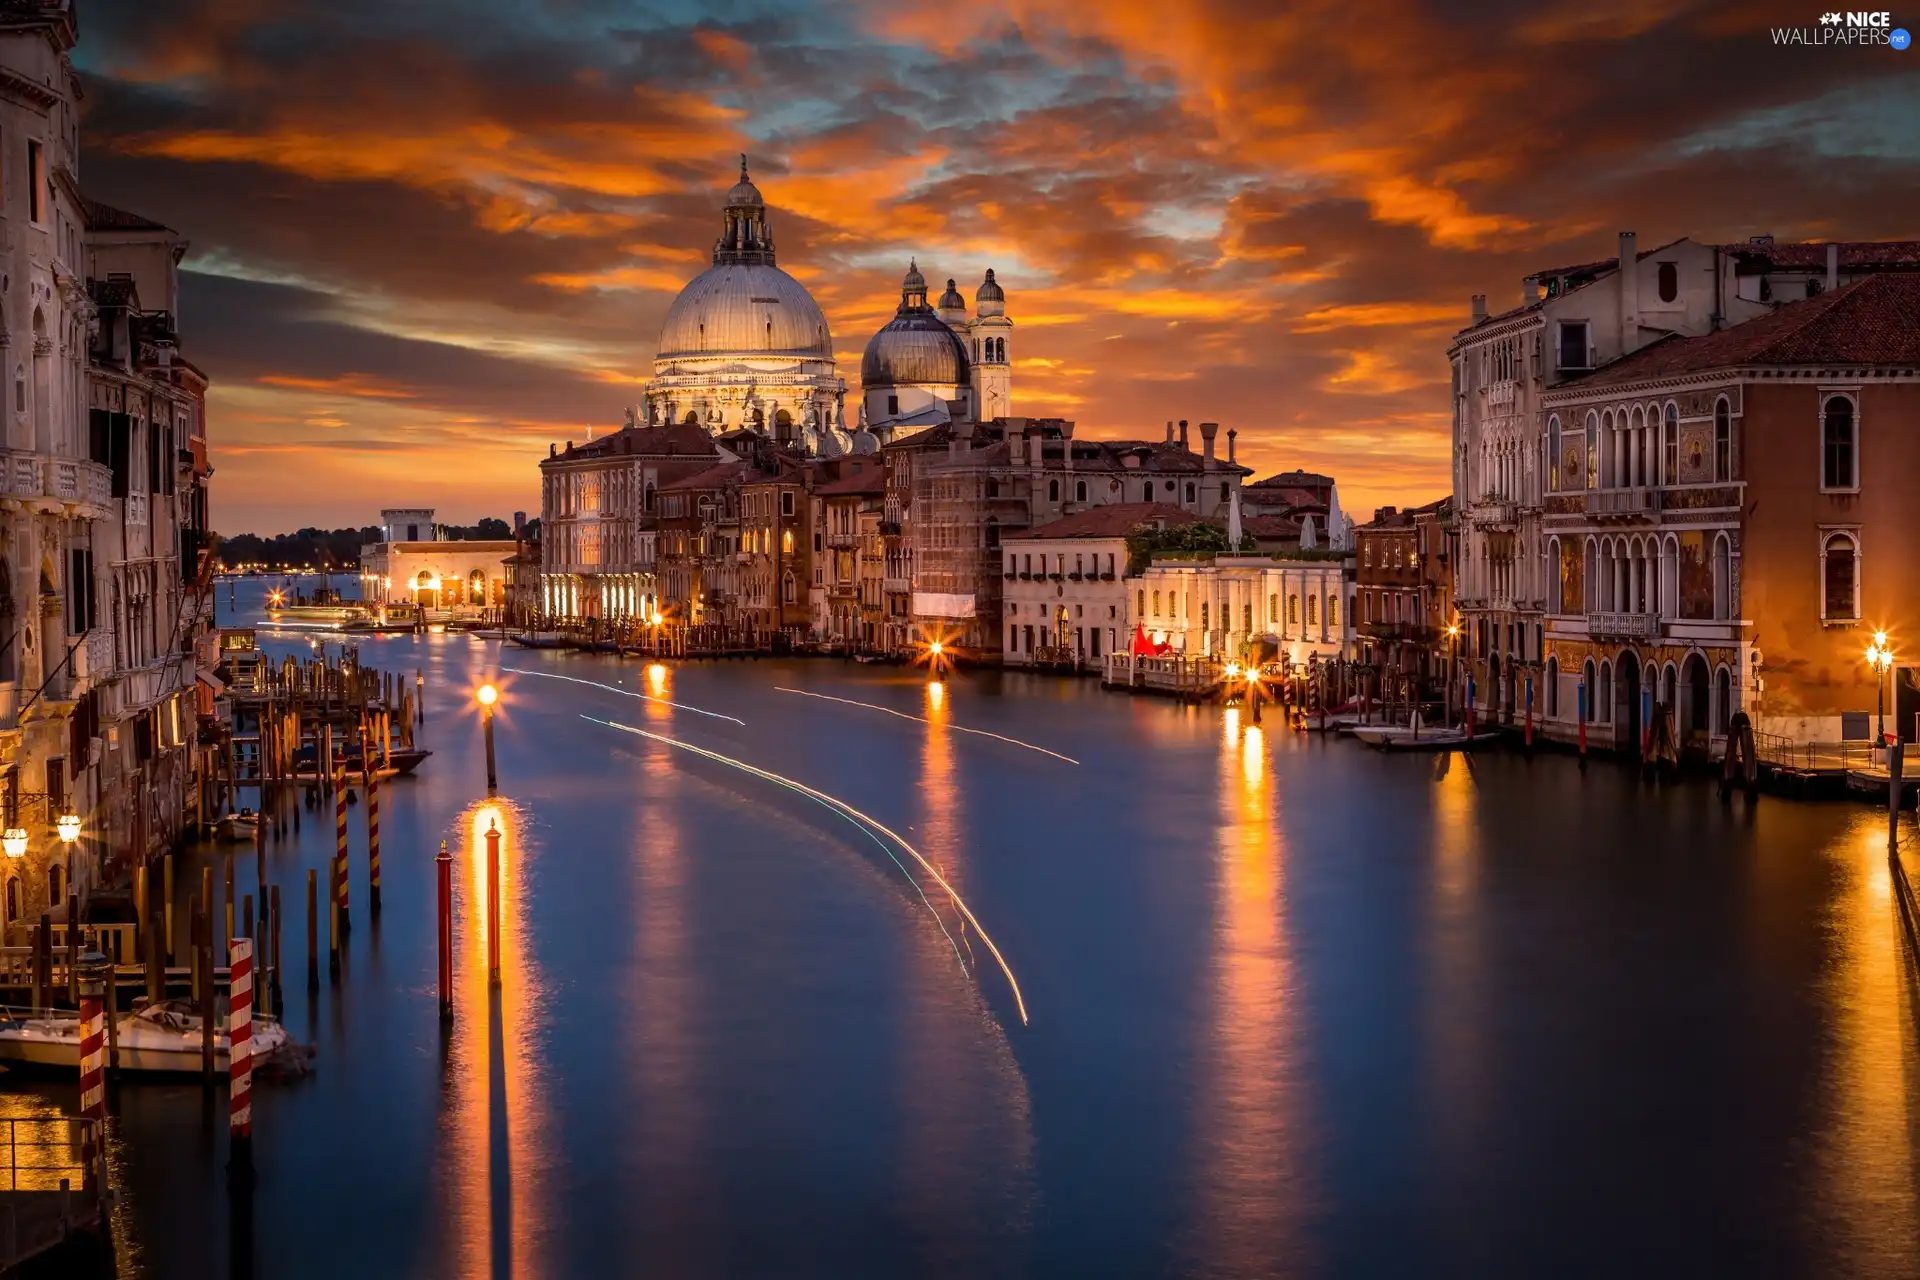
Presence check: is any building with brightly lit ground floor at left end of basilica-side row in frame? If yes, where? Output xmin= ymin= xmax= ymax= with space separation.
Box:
xmin=540 ymin=413 xmax=721 ymax=620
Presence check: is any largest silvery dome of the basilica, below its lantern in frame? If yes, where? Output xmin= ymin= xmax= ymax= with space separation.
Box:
xmin=655 ymin=263 xmax=833 ymax=361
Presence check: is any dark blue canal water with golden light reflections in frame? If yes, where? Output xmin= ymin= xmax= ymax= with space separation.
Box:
xmin=33 ymin=583 xmax=1920 ymax=1280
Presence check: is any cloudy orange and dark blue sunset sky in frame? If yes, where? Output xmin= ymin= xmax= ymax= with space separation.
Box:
xmin=75 ymin=0 xmax=1920 ymax=533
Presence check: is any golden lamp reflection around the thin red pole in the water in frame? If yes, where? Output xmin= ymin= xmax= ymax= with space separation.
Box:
xmin=440 ymin=798 xmax=551 ymax=1280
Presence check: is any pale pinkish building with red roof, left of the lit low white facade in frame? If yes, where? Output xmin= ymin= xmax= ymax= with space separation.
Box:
xmin=1000 ymin=503 xmax=1202 ymax=672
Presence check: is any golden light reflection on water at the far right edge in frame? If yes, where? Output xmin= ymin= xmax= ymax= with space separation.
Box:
xmin=1820 ymin=816 xmax=1920 ymax=1276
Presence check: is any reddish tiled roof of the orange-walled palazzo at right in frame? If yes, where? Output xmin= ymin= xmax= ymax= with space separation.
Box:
xmin=1571 ymin=274 xmax=1920 ymax=388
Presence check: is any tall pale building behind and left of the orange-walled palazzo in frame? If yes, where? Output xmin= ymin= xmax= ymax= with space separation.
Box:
xmin=1448 ymin=232 xmax=1920 ymax=718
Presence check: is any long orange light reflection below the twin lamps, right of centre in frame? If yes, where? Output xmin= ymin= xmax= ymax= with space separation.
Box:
xmin=1194 ymin=708 xmax=1308 ymax=1276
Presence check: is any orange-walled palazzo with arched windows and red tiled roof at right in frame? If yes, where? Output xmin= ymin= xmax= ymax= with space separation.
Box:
xmin=1542 ymin=268 xmax=1920 ymax=754
